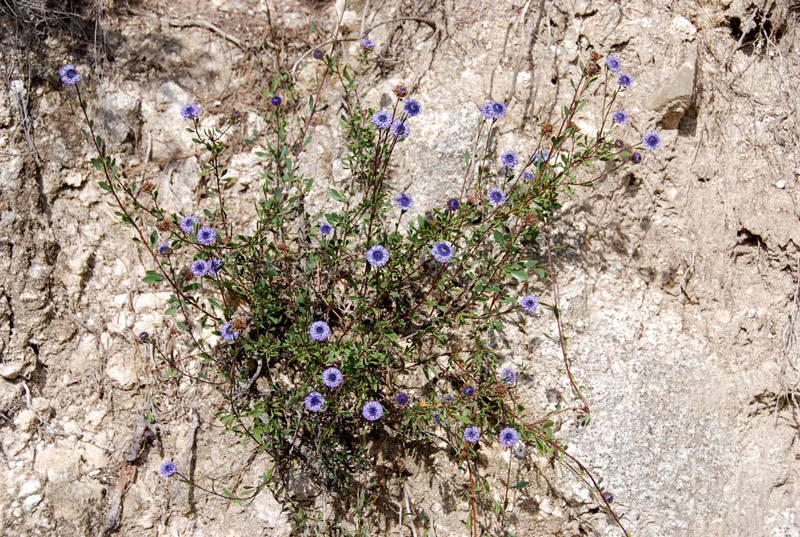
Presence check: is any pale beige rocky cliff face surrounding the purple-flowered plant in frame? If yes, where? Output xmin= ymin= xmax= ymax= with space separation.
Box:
xmin=0 ymin=0 xmax=800 ymax=536
